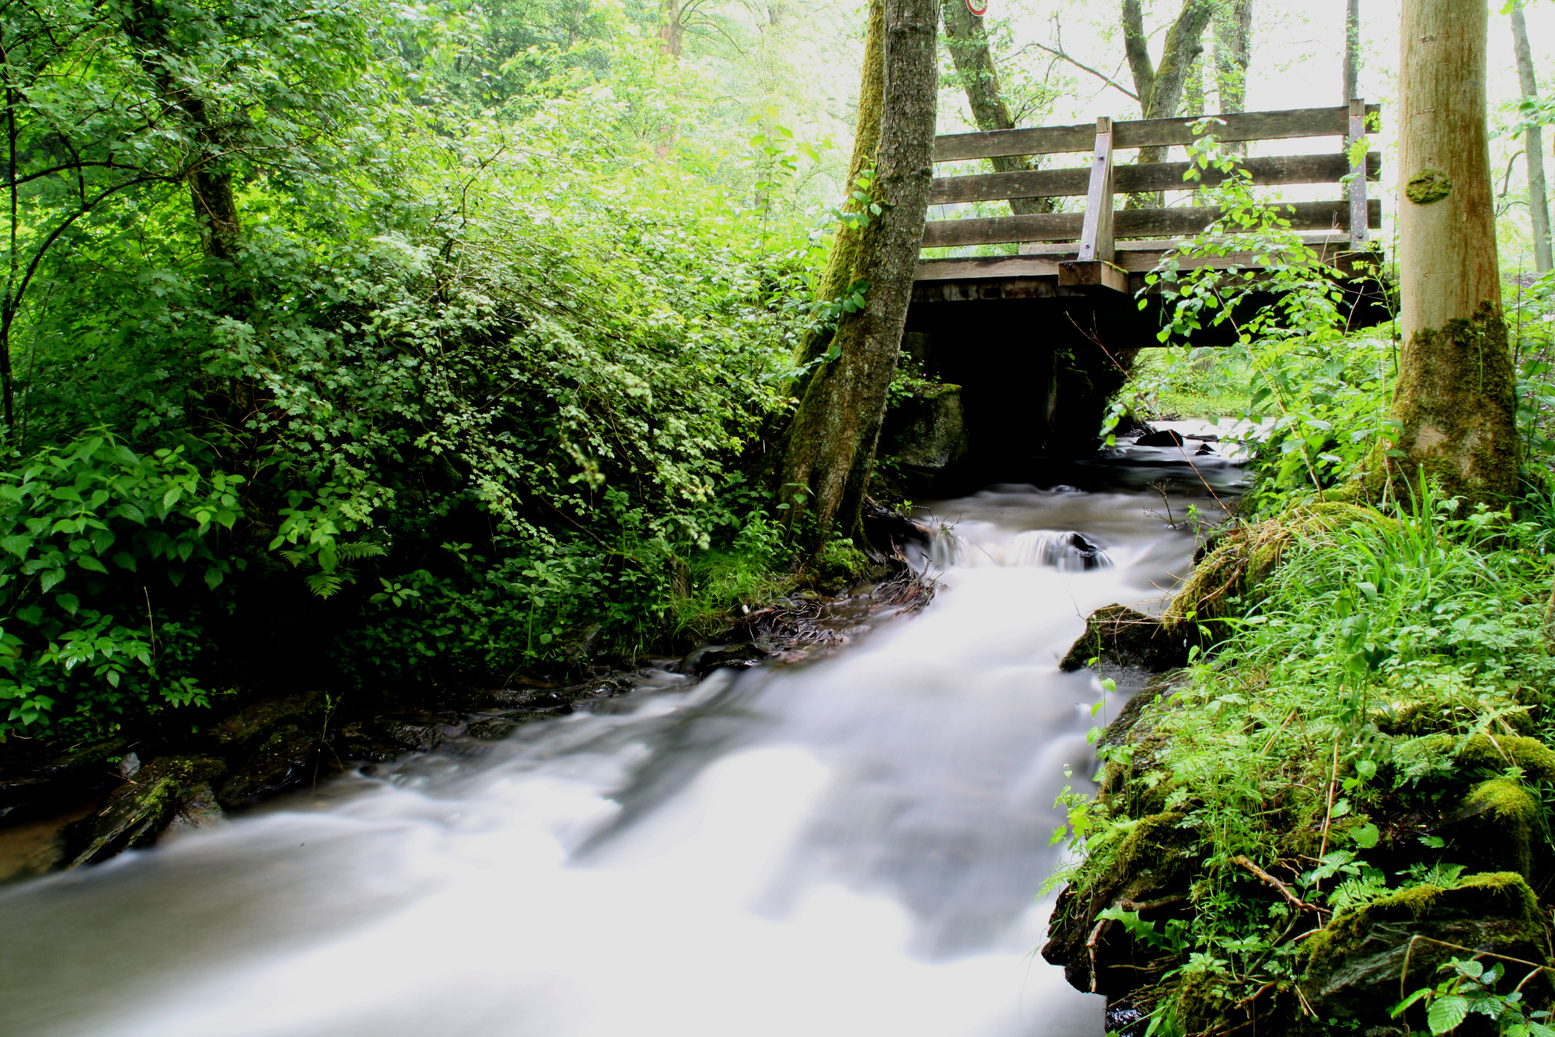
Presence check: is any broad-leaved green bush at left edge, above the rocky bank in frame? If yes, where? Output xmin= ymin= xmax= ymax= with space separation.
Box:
xmin=0 ymin=435 xmax=243 ymax=738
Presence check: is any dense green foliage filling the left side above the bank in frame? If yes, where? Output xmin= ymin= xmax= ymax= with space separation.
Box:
xmin=0 ymin=0 xmax=864 ymax=738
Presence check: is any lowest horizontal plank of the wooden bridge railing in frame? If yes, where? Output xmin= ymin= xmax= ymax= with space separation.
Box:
xmin=924 ymin=199 xmax=1382 ymax=249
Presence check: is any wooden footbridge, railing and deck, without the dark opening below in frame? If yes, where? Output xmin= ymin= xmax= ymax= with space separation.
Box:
xmin=910 ymin=101 xmax=1382 ymax=337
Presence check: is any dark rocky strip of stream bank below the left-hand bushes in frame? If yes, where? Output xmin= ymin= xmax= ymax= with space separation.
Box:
xmin=0 ymin=550 xmax=933 ymax=883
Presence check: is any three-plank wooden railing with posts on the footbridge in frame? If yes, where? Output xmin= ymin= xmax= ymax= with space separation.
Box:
xmin=919 ymin=100 xmax=1382 ymax=291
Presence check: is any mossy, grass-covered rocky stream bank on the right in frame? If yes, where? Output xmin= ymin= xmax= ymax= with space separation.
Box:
xmin=1042 ymin=502 xmax=1555 ymax=1037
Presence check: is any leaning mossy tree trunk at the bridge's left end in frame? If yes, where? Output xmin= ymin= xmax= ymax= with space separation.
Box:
xmin=778 ymin=0 xmax=939 ymax=547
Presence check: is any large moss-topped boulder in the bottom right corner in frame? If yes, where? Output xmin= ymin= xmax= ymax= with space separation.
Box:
xmin=1302 ymin=872 xmax=1549 ymax=1031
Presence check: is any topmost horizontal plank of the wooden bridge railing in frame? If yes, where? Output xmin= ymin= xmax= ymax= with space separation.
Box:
xmin=935 ymin=104 xmax=1382 ymax=162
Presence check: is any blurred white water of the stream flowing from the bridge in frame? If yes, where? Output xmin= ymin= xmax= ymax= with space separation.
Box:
xmin=0 ymin=469 xmax=1219 ymax=1037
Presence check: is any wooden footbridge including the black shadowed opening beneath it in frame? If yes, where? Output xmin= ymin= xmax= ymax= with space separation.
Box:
xmin=903 ymin=101 xmax=1387 ymax=478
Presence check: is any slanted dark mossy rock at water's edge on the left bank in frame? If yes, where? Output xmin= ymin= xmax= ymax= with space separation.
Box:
xmin=65 ymin=756 xmax=227 ymax=869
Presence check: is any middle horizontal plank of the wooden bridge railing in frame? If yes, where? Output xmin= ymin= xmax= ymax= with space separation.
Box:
xmin=928 ymin=151 xmax=1382 ymax=205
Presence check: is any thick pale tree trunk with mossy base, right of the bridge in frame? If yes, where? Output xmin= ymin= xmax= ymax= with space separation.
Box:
xmin=1390 ymin=0 xmax=1518 ymax=501
